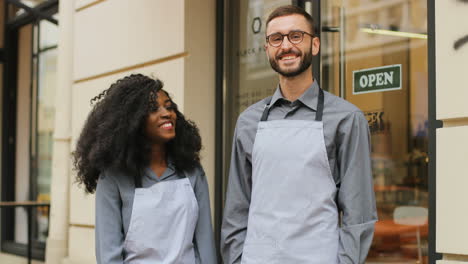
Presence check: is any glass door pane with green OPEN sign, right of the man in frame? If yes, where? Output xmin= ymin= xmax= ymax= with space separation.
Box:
xmin=322 ymin=0 xmax=428 ymax=263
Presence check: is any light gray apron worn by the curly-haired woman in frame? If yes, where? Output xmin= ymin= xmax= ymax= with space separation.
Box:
xmin=124 ymin=174 xmax=198 ymax=264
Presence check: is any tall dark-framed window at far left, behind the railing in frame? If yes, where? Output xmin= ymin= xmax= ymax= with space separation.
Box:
xmin=3 ymin=14 xmax=58 ymax=258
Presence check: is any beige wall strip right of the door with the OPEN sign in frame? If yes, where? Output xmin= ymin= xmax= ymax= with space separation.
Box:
xmin=435 ymin=0 xmax=468 ymax=264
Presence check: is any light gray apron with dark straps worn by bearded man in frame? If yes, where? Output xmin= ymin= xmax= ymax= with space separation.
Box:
xmin=242 ymin=89 xmax=339 ymax=264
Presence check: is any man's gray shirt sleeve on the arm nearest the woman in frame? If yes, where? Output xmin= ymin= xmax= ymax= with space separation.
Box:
xmin=221 ymin=127 xmax=252 ymax=264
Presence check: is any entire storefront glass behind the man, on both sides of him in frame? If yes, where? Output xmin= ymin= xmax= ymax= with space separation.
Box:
xmin=224 ymin=0 xmax=429 ymax=263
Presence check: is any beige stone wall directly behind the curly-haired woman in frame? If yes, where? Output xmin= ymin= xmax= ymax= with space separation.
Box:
xmin=64 ymin=0 xmax=216 ymax=264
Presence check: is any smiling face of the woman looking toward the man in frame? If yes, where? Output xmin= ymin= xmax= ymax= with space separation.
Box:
xmin=145 ymin=90 xmax=177 ymax=144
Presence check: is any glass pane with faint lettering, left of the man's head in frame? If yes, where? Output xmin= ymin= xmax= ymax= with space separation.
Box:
xmin=223 ymin=0 xmax=291 ymax=197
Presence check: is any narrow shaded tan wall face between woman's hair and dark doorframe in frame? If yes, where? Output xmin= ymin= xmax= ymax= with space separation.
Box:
xmin=184 ymin=0 xmax=221 ymax=215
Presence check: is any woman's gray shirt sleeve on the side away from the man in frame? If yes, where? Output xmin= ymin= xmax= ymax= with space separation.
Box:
xmin=95 ymin=170 xmax=125 ymax=264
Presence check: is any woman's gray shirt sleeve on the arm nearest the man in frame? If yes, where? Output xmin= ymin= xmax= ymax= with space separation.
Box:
xmin=194 ymin=170 xmax=217 ymax=264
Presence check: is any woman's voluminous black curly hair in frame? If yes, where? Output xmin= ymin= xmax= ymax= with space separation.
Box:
xmin=73 ymin=74 xmax=201 ymax=193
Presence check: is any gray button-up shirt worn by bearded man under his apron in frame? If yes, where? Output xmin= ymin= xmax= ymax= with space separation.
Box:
xmin=221 ymin=82 xmax=377 ymax=264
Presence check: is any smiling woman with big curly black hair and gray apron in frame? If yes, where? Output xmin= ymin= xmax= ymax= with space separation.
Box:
xmin=74 ymin=74 xmax=216 ymax=264
